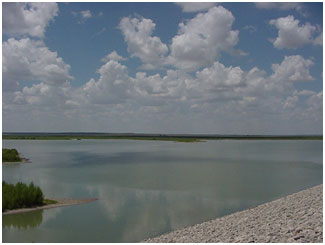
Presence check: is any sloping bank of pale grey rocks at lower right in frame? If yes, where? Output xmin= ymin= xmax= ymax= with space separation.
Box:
xmin=141 ymin=184 xmax=323 ymax=243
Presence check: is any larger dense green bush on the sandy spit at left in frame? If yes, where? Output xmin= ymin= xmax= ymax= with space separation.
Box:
xmin=2 ymin=181 xmax=44 ymax=211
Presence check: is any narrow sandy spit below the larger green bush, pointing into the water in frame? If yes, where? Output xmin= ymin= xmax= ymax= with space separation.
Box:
xmin=2 ymin=198 xmax=98 ymax=216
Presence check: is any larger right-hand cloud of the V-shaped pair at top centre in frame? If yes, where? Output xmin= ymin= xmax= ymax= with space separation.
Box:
xmin=168 ymin=6 xmax=239 ymax=70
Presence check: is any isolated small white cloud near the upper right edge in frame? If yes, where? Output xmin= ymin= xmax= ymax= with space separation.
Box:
xmin=270 ymin=15 xmax=322 ymax=49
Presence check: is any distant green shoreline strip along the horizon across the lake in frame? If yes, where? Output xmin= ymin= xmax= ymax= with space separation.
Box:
xmin=2 ymin=132 xmax=323 ymax=142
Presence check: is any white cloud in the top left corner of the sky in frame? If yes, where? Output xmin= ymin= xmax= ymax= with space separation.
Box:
xmin=2 ymin=2 xmax=59 ymax=38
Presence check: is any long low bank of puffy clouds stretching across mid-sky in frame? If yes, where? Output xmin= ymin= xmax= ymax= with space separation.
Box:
xmin=15 ymin=56 xmax=314 ymax=111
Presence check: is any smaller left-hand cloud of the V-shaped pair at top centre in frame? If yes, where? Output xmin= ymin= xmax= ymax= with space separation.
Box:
xmin=119 ymin=17 xmax=168 ymax=69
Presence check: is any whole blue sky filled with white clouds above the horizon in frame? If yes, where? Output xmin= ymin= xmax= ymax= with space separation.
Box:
xmin=2 ymin=2 xmax=323 ymax=134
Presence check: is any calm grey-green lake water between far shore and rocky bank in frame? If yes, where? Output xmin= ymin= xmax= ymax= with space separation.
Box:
xmin=2 ymin=140 xmax=323 ymax=242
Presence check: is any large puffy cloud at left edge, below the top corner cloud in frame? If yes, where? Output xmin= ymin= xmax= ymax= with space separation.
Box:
xmin=2 ymin=38 xmax=73 ymax=91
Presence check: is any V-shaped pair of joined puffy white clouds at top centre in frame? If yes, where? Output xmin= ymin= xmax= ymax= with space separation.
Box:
xmin=119 ymin=6 xmax=246 ymax=71
